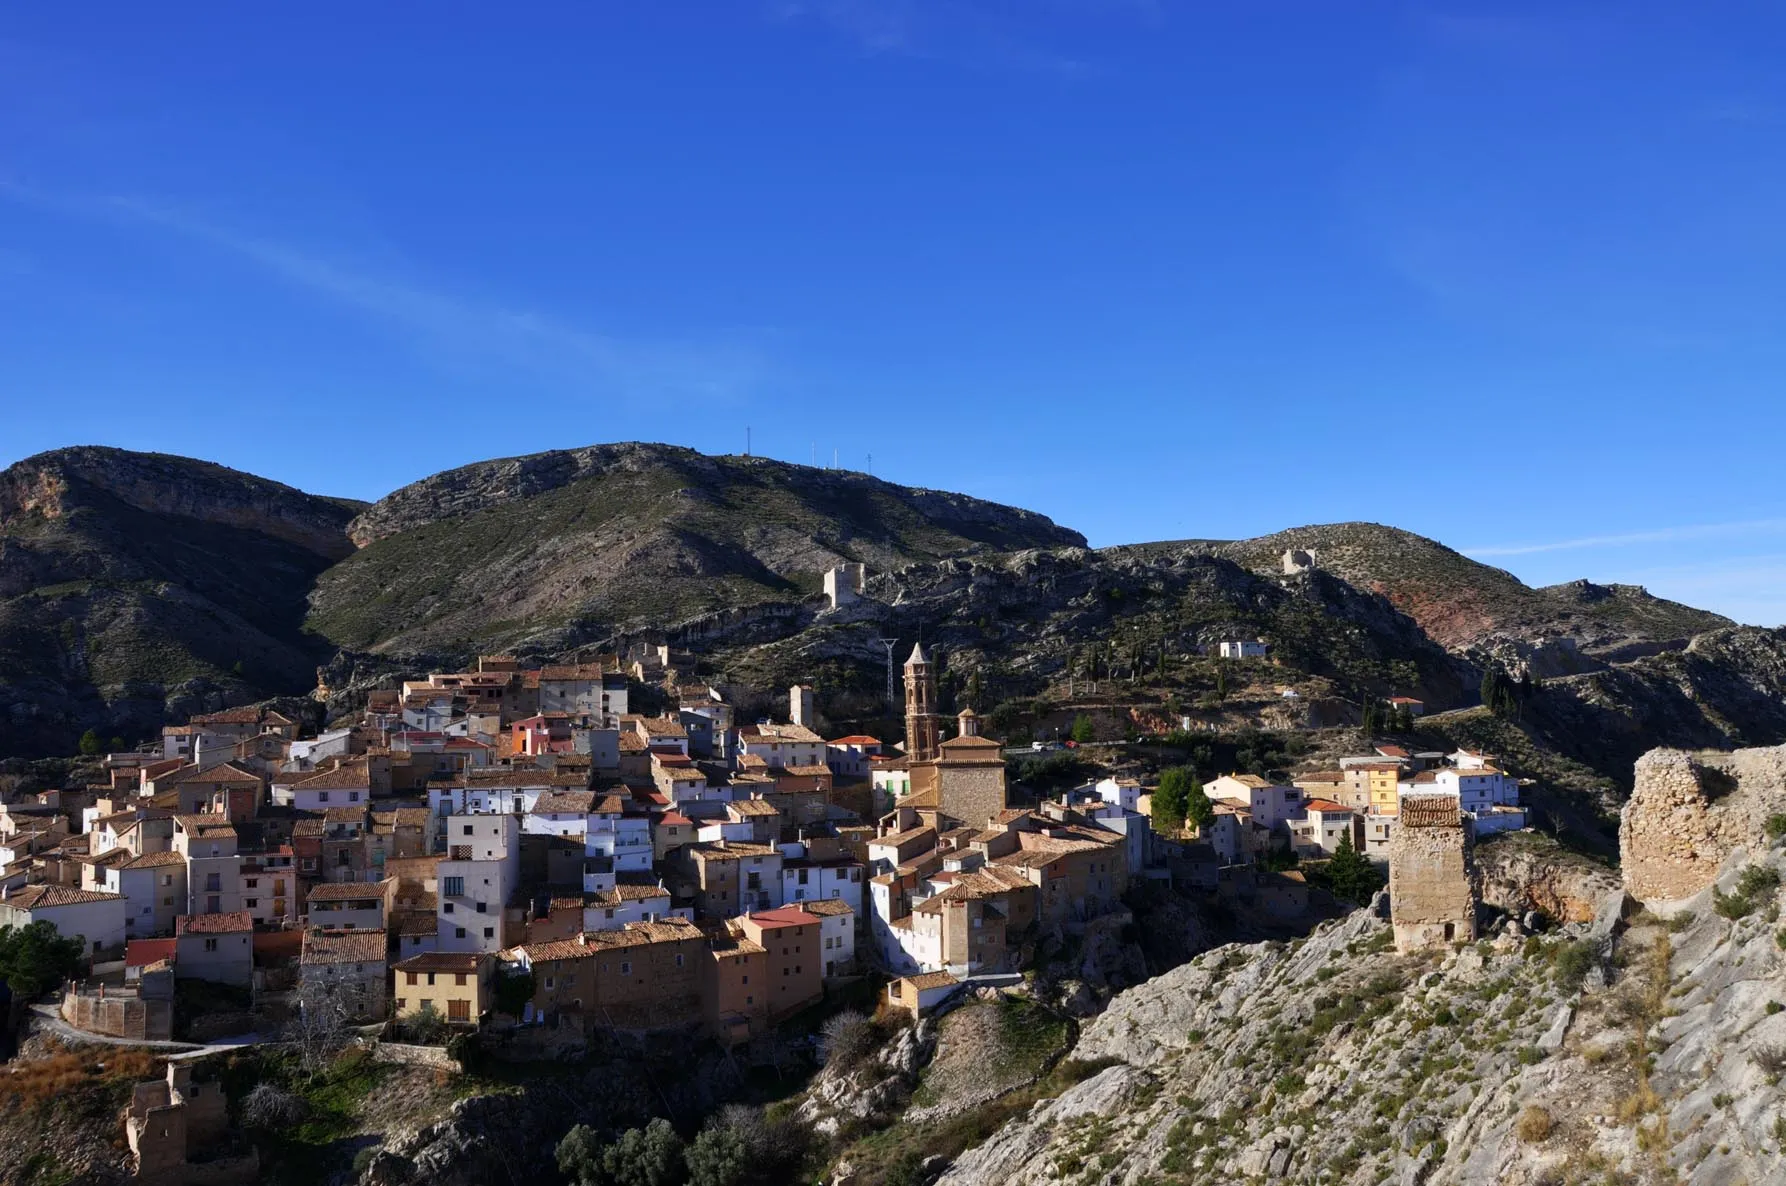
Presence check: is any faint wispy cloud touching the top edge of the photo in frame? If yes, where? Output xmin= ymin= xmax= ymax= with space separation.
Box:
xmin=768 ymin=0 xmax=1091 ymax=77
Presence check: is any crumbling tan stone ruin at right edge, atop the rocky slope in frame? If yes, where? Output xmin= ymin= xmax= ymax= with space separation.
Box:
xmin=1618 ymin=747 xmax=1786 ymax=900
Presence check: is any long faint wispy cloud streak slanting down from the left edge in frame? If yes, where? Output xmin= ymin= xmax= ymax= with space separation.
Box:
xmin=0 ymin=180 xmax=763 ymax=398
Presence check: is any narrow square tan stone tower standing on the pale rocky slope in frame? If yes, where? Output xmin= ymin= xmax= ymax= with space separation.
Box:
xmin=1390 ymin=795 xmax=1477 ymax=952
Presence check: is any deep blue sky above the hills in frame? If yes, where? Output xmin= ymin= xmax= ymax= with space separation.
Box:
xmin=0 ymin=0 xmax=1786 ymax=625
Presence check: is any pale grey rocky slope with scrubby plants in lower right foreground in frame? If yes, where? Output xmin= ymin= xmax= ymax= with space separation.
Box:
xmin=939 ymin=839 xmax=1786 ymax=1186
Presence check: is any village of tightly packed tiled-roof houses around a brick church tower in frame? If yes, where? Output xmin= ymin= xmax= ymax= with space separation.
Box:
xmin=0 ymin=621 xmax=1523 ymax=1064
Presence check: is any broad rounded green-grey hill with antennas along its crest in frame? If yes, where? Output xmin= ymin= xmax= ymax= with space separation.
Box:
xmin=311 ymin=445 xmax=1084 ymax=652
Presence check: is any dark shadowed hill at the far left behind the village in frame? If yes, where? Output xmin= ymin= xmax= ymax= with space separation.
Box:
xmin=0 ymin=448 xmax=359 ymax=757
